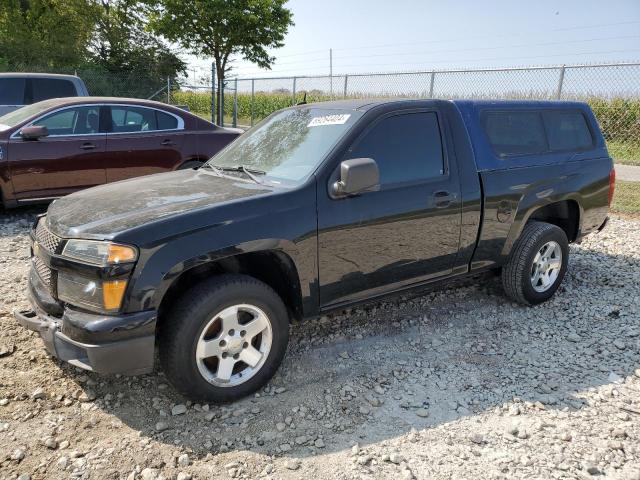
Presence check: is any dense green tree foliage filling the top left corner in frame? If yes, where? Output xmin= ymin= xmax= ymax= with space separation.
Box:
xmin=0 ymin=0 xmax=96 ymax=70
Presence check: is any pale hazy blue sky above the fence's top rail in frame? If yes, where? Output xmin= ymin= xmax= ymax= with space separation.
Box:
xmin=182 ymin=0 xmax=640 ymax=80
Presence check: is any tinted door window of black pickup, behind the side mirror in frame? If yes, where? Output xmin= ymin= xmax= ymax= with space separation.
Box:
xmin=349 ymin=112 xmax=444 ymax=185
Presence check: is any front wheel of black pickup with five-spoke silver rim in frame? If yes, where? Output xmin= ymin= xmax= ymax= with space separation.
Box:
xmin=158 ymin=275 xmax=289 ymax=403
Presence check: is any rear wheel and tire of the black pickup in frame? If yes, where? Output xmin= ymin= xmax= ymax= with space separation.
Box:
xmin=502 ymin=222 xmax=569 ymax=305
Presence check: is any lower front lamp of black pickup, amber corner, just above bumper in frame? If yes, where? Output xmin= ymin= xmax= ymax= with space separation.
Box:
xmin=58 ymin=271 xmax=127 ymax=313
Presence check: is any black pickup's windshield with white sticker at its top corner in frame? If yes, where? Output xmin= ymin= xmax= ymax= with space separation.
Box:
xmin=207 ymin=106 xmax=362 ymax=184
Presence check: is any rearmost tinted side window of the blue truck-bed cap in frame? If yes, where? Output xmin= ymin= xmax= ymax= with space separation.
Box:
xmin=544 ymin=111 xmax=593 ymax=150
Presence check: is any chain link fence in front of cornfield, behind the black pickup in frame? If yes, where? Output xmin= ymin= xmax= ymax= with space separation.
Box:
xmin=200 ymin=63 xmax=640 ymax=165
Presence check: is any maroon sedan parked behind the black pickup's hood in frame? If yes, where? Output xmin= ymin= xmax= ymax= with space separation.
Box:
xmin=0 ymin=97 xmax=241 ymax=207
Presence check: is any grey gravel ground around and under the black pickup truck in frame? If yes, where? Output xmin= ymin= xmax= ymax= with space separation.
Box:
xmin=0 ymin=210 xmax=640 ymax=480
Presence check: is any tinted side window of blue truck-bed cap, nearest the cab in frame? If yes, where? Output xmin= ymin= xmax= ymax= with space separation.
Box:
xmin=483 ymin=111 xmax=549 ymax=157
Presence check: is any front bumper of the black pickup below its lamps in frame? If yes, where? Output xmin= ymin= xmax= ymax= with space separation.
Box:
xmin=14 ymin=269 xmax=156 ymax=375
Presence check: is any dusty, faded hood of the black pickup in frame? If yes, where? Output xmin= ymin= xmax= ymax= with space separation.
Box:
xmin=47 ymin=170 xmax=272 ymax=238
